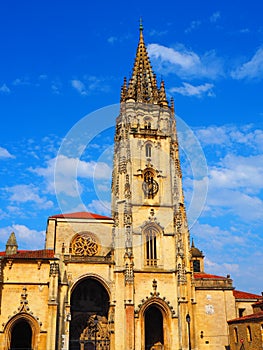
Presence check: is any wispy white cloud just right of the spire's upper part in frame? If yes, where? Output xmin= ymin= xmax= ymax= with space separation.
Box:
xmin=148 ymin=44 xmax=223 ymax=79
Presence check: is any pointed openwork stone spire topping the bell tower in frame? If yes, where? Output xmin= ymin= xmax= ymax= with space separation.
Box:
xmin=121 ymin=22 xmax=168 ymax=107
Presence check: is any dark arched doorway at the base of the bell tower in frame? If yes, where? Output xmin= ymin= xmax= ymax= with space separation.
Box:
xmin=144 ymin=305 xmax=164 ymax=350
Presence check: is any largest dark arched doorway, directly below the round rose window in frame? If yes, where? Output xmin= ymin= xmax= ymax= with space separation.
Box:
xmin=69 ymin=278 xmax=109 ymax=350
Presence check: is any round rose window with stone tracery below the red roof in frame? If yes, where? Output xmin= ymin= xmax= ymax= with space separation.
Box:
xmin=72 ymin=233 xmax=99 ymax=256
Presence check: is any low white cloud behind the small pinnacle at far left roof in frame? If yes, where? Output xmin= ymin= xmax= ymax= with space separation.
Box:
xmin=0 ymin=224 xmax=45 ymax=250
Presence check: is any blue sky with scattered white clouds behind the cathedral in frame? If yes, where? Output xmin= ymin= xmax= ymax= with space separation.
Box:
xmin=0 ymin=0 xmax=263 ymax=293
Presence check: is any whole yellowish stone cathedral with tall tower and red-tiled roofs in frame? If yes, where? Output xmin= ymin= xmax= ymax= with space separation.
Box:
xmin=0 ymin=26 xmax=260 ymax=350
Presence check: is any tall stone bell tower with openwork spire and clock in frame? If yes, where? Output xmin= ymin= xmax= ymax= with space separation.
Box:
xmin=112 ymin=24 xmax=193 ymax=349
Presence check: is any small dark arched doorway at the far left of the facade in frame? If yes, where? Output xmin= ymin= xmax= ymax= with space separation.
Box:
xmin=10 ymin=319 xmax=32 ymax=350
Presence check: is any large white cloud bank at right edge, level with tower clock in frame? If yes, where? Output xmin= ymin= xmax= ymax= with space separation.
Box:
xmin=198 ymin=154 xmax=263 ymax=220
